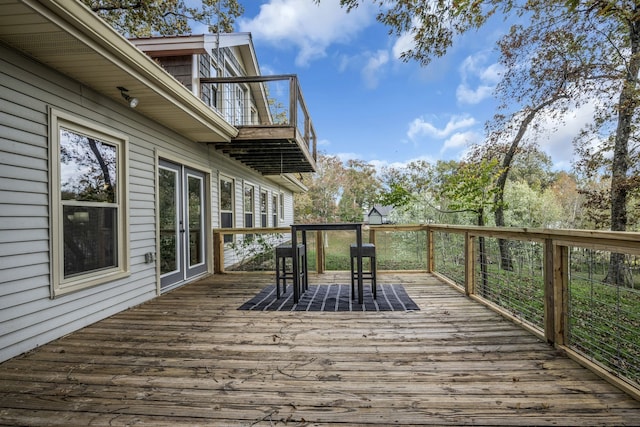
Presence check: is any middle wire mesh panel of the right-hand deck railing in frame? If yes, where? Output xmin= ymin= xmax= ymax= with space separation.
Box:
xmin=474 ymin=237 xmax=544 ymax=330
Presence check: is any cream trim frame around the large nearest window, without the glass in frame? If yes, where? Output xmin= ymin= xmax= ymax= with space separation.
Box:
xmin=49 ymin=108 xmax=131 ymax=298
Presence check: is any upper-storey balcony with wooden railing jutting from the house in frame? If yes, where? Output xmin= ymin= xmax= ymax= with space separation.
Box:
xmin=200 ymin=75 xmax=317 ymax=175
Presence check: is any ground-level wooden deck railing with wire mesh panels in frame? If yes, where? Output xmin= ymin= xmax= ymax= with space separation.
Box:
xmin=214 ymin=225 xmax=640 ymax=398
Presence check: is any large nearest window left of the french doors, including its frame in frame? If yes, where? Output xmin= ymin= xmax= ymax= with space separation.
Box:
xmin=51 ymin=110 xmax=129 ymax=296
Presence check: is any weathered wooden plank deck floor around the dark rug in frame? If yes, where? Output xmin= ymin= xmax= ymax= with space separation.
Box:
xmin=0 ymin=274 xmax=640 ymax=426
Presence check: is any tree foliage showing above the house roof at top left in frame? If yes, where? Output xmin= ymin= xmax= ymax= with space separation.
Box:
xmin=82 ymin=0 xmax=244 ymax=37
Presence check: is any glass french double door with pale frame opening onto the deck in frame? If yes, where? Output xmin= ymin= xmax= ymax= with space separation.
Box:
xmin=158 ymin=160 xmax=208 ymax=291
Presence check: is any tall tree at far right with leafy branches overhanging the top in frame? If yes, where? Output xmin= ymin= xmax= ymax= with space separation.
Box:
xmin=330 ymin=0 xmax=640 ymax=283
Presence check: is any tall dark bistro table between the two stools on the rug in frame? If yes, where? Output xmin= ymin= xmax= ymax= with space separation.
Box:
xmin=291 ymin=222 xmax=363 ymax=304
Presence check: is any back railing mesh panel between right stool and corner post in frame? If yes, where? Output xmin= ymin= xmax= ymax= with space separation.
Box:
xmin=376 ymin=230 xmax=429 ymax=271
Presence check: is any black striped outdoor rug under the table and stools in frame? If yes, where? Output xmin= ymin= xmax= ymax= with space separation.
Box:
xmin=238 ymin=284 xmax=420 ymax=311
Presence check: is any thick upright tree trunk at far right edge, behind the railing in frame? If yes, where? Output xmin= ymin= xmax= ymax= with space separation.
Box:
xmin=604 ymin=14 xmax=640 ymax=286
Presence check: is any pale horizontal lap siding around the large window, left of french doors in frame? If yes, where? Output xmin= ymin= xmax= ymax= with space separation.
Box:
xmin=0 ymin=46 xmax=208 ymax=361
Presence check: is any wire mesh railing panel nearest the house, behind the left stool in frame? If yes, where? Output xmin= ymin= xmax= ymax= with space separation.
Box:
xmin=224 ymin=233 xmax=291 ymax=271
